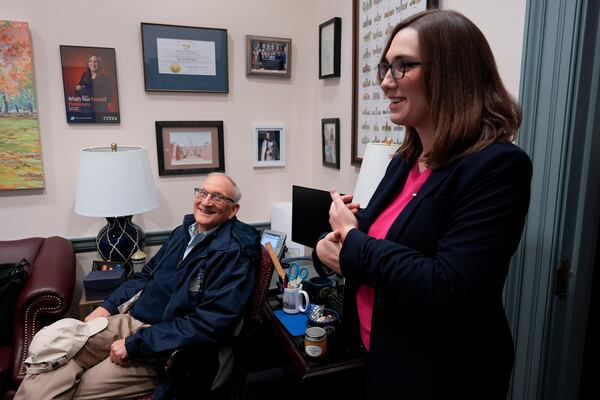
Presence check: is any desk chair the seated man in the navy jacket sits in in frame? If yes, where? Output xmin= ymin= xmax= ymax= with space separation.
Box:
xmin=159 ymin=247 xmax=273 ymax=399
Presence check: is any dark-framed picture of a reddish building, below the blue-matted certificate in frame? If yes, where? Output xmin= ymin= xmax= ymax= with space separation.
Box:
xmin=155 ymin=121 xmax=225 ymax=176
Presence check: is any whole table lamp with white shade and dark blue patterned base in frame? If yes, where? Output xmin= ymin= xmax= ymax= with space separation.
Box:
xmin=75 ymin=143 xmax=158 ymax=264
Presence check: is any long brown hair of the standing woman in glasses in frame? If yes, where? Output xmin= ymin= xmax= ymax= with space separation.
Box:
xmin=381 ymin=9 xmax=521 ymax=169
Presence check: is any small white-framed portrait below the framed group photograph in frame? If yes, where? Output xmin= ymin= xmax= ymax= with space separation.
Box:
xmin=252 ymin=126 xmax=285 ymax=167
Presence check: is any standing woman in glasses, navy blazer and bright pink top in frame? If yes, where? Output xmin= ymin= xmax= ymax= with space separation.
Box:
xmin=315 ymin=10 xmax=532 ymax=399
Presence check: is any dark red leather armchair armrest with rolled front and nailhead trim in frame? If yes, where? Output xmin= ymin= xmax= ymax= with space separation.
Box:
xmin=11 ymin=236 xmax=75 ymax=380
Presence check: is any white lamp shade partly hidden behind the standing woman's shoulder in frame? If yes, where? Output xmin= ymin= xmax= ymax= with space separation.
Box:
xmin=352 ymin=143 xmax=400 ymax=208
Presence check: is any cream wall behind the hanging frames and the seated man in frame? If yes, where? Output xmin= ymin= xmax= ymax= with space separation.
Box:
xmin=0 ymin=0 xmax=525 ymax=314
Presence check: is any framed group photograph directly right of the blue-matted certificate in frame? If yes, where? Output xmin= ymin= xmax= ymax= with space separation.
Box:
xmin=246 ymin=35 xmax=292 ymax=78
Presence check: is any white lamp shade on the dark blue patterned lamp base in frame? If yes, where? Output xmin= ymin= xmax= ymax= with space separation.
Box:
xmin=75 ymin=147 xmax=158 ymax=217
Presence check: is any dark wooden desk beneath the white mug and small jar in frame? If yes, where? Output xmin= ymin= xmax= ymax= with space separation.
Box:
xmin=264 ymin=296 xmax=365 ymax=380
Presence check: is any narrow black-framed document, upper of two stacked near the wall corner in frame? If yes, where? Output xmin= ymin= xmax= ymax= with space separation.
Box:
xmin=319 ymin=17 xmax=342 ymax=79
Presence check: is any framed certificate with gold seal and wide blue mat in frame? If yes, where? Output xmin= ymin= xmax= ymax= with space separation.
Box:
xmin=142 ymin=22 xmax=229 ymax=93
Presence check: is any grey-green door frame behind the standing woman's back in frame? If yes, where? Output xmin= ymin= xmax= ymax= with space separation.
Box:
xmin=505 ymin=0 xmax=600 ymax=400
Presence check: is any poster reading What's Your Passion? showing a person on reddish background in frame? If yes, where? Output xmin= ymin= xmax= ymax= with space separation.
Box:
xmin=60 ymin=45 xmax=121 ymax=124
